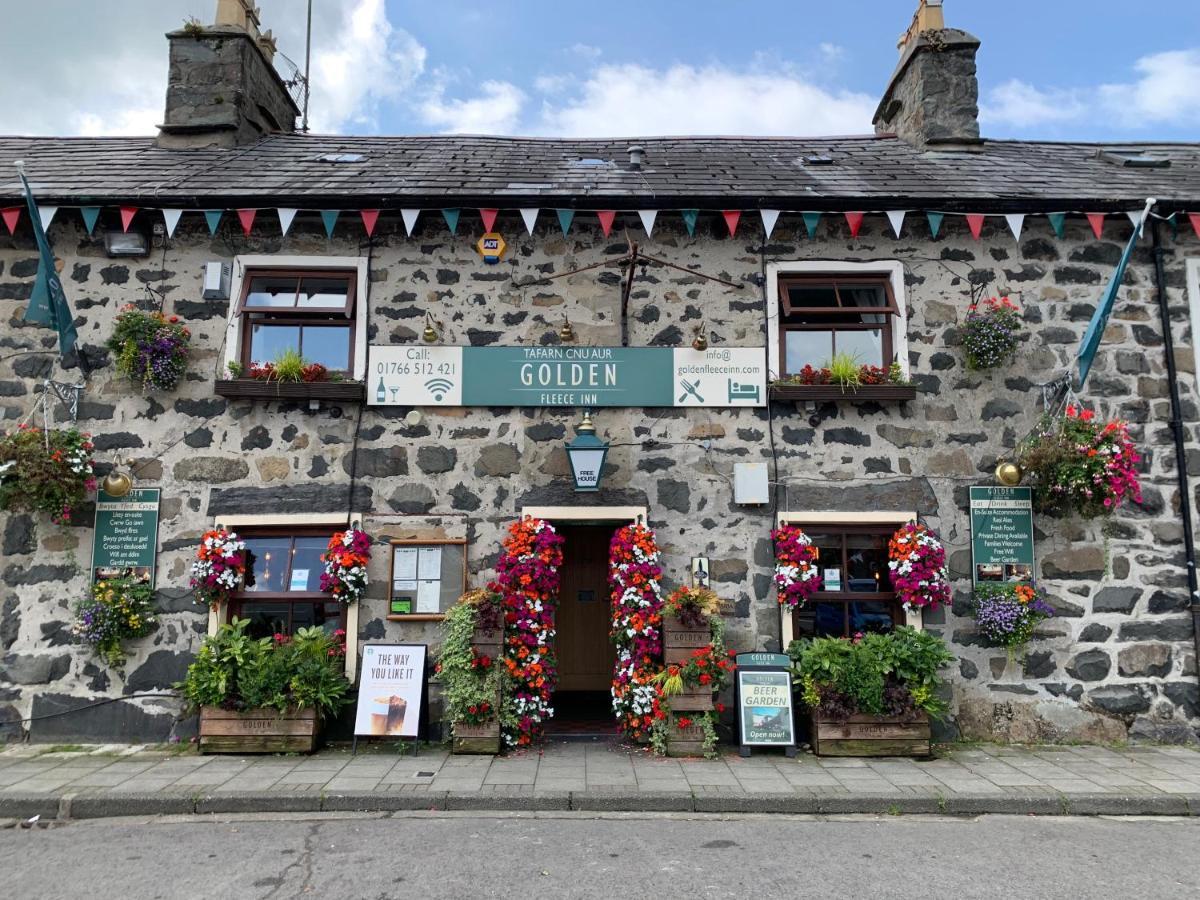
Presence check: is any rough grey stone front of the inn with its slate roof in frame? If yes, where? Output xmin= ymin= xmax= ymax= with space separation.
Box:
xmin=0 ymin=1 xmax=1200 ymax=740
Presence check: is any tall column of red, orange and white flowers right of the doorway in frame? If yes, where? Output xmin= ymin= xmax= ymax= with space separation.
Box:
xmin=608 ymin=523 xmax=662 ymax=742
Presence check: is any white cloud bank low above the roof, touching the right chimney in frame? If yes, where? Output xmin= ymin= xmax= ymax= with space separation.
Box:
xmin=534 ymin=64 xmax=876 ymax=137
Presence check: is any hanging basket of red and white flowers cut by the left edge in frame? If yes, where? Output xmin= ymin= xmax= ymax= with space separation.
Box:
xmin=0 ymin=425 xmax=96 ymax=524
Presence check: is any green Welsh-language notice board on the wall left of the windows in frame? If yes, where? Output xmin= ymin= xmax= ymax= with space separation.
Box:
xmin=91 ymin=487 xmax=162 ymax=587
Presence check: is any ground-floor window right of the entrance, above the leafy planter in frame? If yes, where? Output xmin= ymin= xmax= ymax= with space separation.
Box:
xmin=792 ymin=524 xmax=904 ymax=637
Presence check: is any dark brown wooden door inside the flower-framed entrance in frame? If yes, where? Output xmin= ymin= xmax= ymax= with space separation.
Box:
xmin=556 ymin=524 xmax=617 ymax=691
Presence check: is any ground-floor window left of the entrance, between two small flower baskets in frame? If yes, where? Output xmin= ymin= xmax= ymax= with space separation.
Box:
xmin=229 ymin=527 xmax=346 ymax=637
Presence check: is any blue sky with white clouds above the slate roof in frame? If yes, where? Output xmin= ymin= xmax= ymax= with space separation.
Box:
xmin=0 ymin=0 xmax=1200 ymax=140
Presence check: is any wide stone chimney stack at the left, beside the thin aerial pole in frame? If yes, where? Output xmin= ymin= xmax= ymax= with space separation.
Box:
xmin=158 ymin=0 xmax=300 ymax=148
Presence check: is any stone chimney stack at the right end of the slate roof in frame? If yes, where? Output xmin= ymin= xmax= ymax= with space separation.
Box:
xmin=874 ymin=0 xmax=983 ymax=149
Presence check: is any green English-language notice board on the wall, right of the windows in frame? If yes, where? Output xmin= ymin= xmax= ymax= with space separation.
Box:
xmin=971 ymin=486 xmax=1033 ymax=584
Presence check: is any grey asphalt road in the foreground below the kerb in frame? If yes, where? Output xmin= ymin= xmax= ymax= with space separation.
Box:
xmin=0 ymin=812 xmax=1200 ymax=900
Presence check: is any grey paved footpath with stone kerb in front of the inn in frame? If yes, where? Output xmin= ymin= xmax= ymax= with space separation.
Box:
xmin=0 ymin=744 xmax=1200 ymax=818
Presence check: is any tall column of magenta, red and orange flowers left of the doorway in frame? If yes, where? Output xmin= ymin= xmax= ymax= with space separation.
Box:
xmin=487 ymin=518 xmax=563 ymax=746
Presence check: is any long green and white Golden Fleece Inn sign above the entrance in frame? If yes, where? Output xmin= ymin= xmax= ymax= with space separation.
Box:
xmin=367 ymin=344 xmax=767 ymax=407
